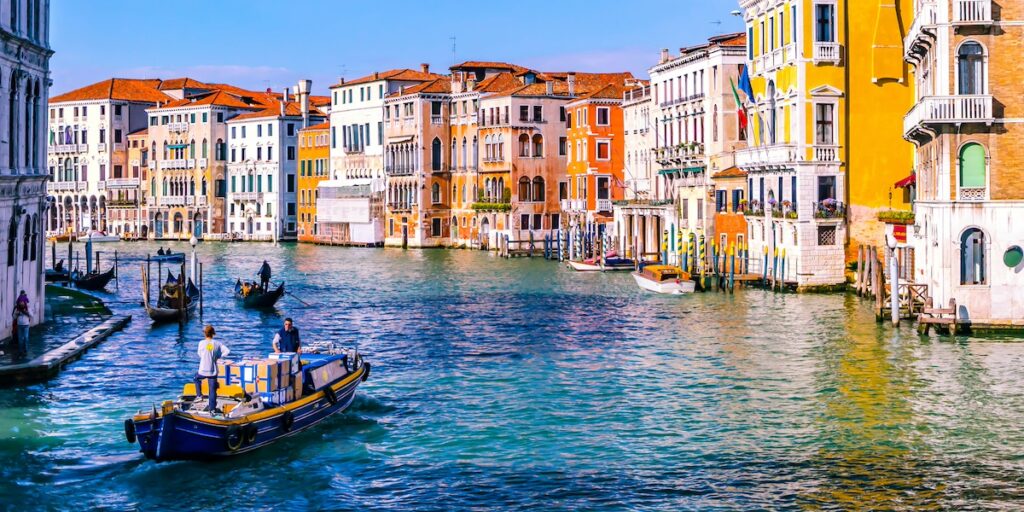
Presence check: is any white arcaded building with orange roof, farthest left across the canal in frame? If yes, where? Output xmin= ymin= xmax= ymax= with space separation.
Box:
xmin=46 ymin=78 xmax=173 ymax=234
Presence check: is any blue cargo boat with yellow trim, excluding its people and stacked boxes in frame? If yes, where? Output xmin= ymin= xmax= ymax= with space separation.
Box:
xmin=124 ymin=347 xmax=370 ymax=462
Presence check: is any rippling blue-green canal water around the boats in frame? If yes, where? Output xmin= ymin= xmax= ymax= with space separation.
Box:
xmin=0 ymin=244 xmax=1024 ymax=510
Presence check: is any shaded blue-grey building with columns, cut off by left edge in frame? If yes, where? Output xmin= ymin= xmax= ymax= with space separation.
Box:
xmin=0 ymin=0 xmax=53 ymax=339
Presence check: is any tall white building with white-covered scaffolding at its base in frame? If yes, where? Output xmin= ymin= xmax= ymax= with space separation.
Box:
xmin=316 ymin=65 xmax=439 ymax=245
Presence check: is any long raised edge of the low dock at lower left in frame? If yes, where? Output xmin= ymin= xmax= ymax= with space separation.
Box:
xmin=0 ymin=315 xmax=131 ymax=386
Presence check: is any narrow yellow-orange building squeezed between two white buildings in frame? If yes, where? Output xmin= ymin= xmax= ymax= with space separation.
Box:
xmin=296 ymin=122 xmax=331 ymax=242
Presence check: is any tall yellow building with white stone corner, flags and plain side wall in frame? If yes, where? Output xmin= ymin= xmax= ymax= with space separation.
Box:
xmin=736 ymin=0 xmax=913 ymax=288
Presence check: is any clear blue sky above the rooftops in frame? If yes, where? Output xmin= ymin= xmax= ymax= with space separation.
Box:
xmin=50 ymin=0 xmax=743 ymax=95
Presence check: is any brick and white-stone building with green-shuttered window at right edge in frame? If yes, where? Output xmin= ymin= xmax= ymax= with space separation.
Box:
xmin=905 ymin=0 xmax=1024 ymax=328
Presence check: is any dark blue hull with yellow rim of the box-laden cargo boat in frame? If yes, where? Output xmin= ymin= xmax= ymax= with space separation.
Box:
xmin=131 ymin=366 xmax=369 ymax=462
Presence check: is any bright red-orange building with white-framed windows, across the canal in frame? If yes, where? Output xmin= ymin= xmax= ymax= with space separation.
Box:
xmin=559 ymin=83 xmax=626 ymax=232
